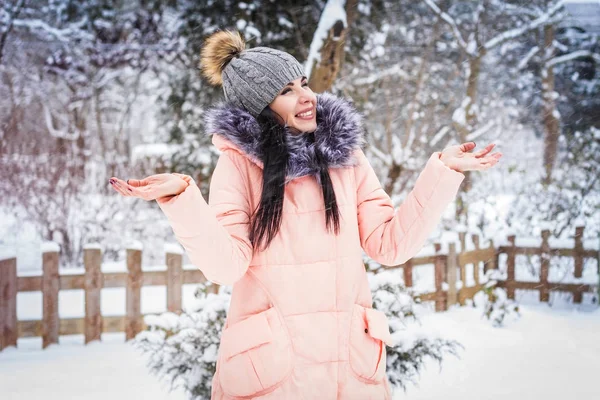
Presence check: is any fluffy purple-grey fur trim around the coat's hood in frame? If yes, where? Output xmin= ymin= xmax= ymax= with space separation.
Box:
xmin=205 ymin=93 xmax=364 ymax=182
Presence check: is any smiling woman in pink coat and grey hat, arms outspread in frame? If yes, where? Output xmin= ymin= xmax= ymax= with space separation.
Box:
xmin=111 ymin=32 xmax=501 ymax=400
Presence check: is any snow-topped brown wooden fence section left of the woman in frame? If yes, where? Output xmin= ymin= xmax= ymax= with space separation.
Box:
xmin=0 ymin=244 xmax=206 ymax=350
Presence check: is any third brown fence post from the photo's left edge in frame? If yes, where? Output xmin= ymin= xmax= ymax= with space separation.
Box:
xmin=83 ymin=243 xmax=104 ymax=344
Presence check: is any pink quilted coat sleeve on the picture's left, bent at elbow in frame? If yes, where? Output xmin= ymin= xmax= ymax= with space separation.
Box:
xmin=157 ymin=151 xmax=252 ymax=285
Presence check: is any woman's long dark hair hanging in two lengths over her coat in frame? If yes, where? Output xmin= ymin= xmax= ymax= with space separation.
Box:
xmin=250 ymin=107 xmax=340 ymax=250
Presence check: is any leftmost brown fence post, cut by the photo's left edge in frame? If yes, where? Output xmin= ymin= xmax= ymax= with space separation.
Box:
xmin=0 ymin=255 xmax=19 ymax=351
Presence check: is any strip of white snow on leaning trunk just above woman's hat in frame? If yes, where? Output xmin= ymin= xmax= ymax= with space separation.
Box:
xmin=304 ymin=0 xmax=348 ymax=79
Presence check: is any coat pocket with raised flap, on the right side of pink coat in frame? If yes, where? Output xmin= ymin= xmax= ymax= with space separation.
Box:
xmin=349 ymin=304 xmax=392 ymax=383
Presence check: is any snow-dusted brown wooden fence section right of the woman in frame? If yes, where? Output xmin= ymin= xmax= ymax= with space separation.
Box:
xmin=376 ymin=226 xmax=600 ymax=311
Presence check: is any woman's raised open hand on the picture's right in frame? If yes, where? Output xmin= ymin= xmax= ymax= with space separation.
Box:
xmin=440 ymin=142 xmax=502 ymax=172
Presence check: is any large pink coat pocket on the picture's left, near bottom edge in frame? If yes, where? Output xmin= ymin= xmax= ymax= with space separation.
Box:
xmin=218 ymin=308 xmax=292 ymax=397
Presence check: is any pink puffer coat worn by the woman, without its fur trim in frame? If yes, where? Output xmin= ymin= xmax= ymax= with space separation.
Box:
xmin=159 ymin=95 xmax=464 ymax=400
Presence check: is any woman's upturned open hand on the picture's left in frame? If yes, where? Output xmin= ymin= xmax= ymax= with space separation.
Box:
xmin=109 ymin=173 xmax=190 ymax=201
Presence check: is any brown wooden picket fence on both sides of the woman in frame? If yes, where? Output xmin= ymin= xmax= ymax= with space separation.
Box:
xmin=0 ymin=227 xmax=600 ymax=350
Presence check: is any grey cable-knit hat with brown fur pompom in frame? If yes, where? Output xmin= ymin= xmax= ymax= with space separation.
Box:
xmin=200 ymin=31 xmax=306 ymax=117
